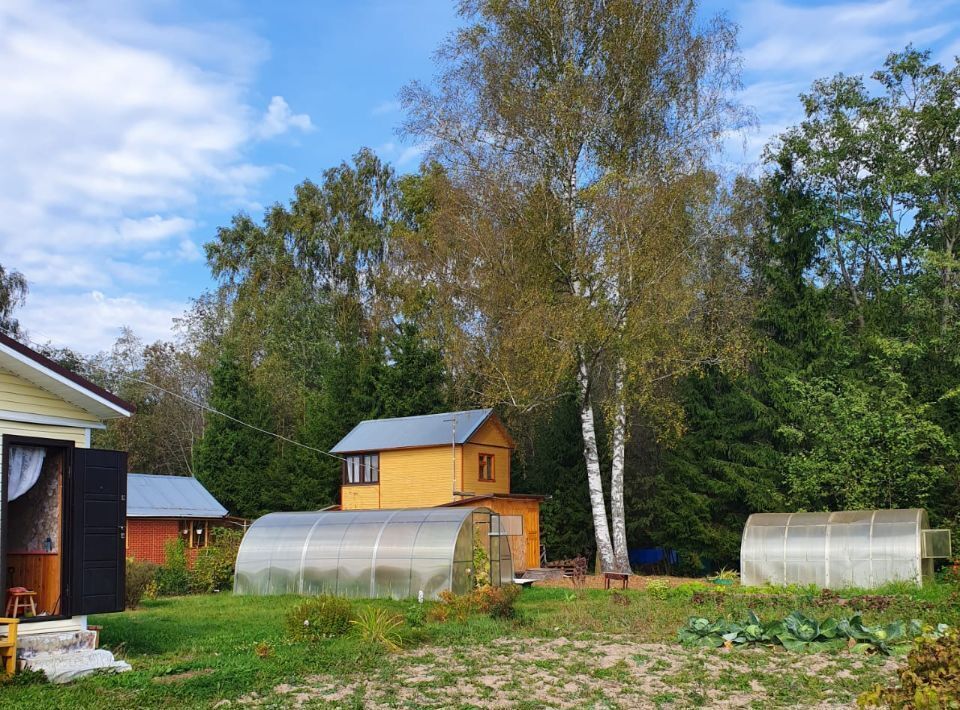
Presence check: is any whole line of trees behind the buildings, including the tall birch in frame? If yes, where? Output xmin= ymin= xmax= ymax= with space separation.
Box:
xmin=0 ymin=0 xmax=960 ymax=568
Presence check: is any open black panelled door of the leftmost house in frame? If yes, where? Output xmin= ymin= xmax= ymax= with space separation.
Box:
xmin=69 ymin=449 xmax=127 ymax=614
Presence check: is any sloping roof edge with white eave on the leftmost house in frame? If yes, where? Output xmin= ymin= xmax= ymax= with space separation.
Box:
xmin=0 ymin=333 xmax=136 ymax=419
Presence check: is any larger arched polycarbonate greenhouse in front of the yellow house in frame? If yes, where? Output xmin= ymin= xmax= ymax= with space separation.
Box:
xmin=234 ymin=507 xmax=513 ymax=599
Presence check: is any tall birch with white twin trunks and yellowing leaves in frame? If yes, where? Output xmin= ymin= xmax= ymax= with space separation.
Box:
xmin=402 ymin=0 xmax=746 ymax=570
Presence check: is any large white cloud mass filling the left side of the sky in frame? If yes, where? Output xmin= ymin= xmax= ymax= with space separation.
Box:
xmin=0 ymin=0 xmax=312 ymax=346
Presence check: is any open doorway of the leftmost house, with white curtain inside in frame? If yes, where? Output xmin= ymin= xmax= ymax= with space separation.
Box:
xmin=2 ymin=437 xmax=72 ymax=621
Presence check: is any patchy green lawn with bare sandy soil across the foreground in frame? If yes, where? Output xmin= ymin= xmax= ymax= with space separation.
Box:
xmin=0 ymin=586 xmax=960 ymax=709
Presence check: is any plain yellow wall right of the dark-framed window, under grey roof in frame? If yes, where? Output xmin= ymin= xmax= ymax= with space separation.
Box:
xmin=380 ymin=446 xmax=460 ymax=508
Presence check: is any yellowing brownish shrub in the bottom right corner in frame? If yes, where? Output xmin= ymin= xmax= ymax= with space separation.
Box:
xmin=857 ymin=630 xmax=960 ymax=710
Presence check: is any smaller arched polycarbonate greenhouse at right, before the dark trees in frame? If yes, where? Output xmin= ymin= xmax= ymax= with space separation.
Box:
xmin=740 ymin=509 xmax=950 ymax=589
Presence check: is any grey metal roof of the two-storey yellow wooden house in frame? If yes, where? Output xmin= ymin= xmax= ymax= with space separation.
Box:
xmin=330 ymin=409 xmax=493 ymax=454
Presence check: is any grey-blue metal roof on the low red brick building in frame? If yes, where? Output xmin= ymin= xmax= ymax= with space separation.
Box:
xmin=127 ymin=473 xmax=227 ymax=518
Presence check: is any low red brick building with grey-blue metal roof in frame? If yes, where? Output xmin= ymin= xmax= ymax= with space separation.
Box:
xmin=127 ymin=473 xmax=227 ymax=564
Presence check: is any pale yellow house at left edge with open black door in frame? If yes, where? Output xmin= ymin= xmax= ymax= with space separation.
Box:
xmin=0 ymin=334 xmax=134 ymax=680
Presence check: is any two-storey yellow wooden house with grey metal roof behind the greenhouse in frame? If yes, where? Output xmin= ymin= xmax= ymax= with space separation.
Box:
xmin=331 ymin=409 xmax=543 ymax=573
